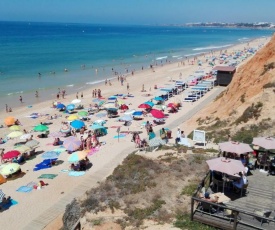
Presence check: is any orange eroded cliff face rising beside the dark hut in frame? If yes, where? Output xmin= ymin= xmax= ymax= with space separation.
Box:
xmin=188 ymin=35 xmax=275 ymax=138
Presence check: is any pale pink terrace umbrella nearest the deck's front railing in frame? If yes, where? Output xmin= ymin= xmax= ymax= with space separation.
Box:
xmin=206 ymin=157 xmax=245 ymax=176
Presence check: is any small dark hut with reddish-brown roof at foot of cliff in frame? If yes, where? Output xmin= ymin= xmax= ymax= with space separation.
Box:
xmin=213 ymin=66 xmax=236 ymax=86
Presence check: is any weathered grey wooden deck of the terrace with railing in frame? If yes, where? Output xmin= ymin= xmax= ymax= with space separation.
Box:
xmin=192 ymin=169 xmax=275 ymax=230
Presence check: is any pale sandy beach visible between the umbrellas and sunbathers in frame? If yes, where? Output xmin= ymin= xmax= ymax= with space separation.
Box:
xmin=0 ymin=38 xmax=269 ymax=229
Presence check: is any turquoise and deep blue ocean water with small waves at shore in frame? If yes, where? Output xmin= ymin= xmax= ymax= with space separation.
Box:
xmin=0 ymin=22 xmax=273 ymax=109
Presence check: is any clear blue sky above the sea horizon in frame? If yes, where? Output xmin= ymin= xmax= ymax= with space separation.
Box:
xmin=0 ymin=0 xmax=275 ymax=24
